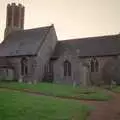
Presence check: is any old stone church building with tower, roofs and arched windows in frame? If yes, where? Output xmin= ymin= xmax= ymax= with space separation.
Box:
xmin=0 ymin=3 xmax=120 ymax=85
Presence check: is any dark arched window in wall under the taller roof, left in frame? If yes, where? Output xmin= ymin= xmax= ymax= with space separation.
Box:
xmin=21 ymin=58 xmax=28 ymax=76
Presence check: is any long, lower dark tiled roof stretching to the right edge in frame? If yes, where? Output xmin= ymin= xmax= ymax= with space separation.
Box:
xmin=52 ymin=35 xmax=120 ymax=57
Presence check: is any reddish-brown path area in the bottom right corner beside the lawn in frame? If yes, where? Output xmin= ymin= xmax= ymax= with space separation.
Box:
xmin=87 ymin=93 xmax=120 ymax=120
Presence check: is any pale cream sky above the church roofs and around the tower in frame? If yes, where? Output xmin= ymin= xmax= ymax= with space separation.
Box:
xmin=0 ymin=0 xmax=120 ymax=42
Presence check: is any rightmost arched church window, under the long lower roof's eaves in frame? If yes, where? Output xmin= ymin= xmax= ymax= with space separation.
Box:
xmin=90 ymin=58 xmax=99 ymax=72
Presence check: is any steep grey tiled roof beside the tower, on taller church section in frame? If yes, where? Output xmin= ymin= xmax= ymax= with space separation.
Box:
xmin=0 ymin=26 xmax=51 ymax=56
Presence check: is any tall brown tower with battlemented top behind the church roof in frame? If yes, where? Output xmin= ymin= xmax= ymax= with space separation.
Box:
xmin=4 ymin=3 xmax=25 ymax=38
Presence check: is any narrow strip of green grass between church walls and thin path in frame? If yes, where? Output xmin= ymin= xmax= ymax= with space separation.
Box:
xmin=0 ymin=82 xmax=111 ymax=100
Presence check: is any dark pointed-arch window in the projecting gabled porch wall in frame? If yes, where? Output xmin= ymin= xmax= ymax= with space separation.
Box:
xmin=64 ymin=60 xmax=71 ymax=76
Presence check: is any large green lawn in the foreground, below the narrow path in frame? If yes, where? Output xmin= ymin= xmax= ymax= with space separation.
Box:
xmin=0 ymin=89 xmax=92 ymax=120
